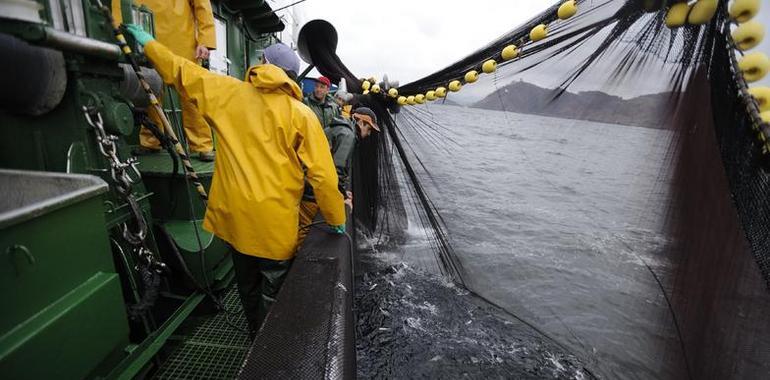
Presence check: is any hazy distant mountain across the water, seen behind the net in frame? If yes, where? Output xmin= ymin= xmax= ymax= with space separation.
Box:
xmin=472 ymin=81 xmax=671 ymax=129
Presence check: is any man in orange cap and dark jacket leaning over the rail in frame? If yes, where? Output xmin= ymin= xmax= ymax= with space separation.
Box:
xmin=299 ymin=107 xmax=380 ymax=244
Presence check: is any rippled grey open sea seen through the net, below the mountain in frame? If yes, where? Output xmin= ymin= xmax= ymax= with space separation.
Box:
xmin=356 ymin=105 xmax=678 ymax=379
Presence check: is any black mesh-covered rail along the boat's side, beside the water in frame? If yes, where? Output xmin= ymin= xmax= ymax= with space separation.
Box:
xmin=238 ymin=224 xmax=355 ymax=379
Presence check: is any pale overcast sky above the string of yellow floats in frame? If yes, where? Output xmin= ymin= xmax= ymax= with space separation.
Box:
xmin=271 ymin=0 xmax=770 ymax=85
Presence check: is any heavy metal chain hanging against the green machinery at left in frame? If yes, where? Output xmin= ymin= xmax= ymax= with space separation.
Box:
xmin=83 ymin=106 xmax=166 ymax=274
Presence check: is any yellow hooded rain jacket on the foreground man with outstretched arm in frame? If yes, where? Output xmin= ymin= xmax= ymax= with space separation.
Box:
xmin=145 ymin=41 xmax=345 ymax=260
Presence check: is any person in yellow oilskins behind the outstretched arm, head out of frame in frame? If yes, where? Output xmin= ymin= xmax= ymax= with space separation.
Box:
xmin=131 ymin=0 xmax=217 ymax=161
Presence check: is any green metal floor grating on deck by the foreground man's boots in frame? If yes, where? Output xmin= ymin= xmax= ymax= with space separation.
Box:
xmin=154 ymin=287 xmax=250 ymax=379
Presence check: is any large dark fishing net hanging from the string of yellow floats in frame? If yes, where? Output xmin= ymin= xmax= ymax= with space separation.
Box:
xmin=308 ymin=0 xmax=770 ymax=379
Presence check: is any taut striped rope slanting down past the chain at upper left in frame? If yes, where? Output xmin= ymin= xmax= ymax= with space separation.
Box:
xmin=97 ymin=0 xmax=209 ymax=206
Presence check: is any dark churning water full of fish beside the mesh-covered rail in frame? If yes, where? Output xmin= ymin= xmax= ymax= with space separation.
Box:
xmin=356 ymin=264 xmax=592 ymax=379
